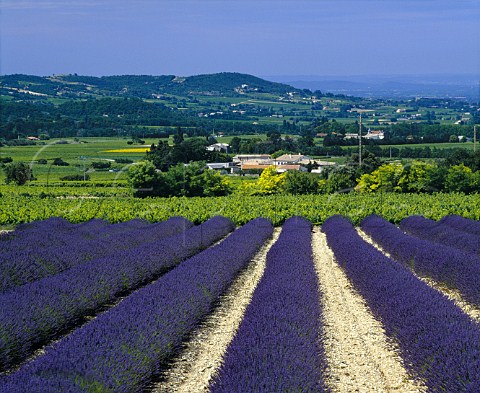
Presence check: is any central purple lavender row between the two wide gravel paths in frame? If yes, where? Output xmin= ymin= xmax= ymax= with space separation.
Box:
xmin=211 ymin=217 xmax=326 ymax=393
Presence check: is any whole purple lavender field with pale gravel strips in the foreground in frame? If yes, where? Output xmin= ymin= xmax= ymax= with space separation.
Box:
xmin=0 ymin=214 xmax=480 ymax=393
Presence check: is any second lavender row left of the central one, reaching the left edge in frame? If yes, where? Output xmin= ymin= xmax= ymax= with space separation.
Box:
xmin=0 ymin=217 xmax=234 ymax=370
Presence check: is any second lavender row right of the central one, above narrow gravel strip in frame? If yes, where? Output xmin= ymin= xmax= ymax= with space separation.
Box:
xmin=361 ymin=216 xmax=480 ymax=306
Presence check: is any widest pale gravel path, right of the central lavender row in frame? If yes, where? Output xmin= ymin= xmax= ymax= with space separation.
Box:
xmin=313 ymin=227 xmax=426 ymax=393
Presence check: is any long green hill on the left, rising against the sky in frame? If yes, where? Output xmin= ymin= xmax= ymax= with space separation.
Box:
xmin=0 ymin=72 xmax=306 ymax=99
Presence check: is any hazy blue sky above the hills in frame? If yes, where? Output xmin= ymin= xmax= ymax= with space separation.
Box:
xmin=0 ymin=0 xmax=480 ymax=76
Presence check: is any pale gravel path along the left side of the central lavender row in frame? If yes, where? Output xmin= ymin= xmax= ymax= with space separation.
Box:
xmin=152 ymin=228 xmax=281 ymax=393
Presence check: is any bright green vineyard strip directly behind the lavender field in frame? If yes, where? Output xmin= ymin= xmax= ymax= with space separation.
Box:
xmin=0 ymin=191 xmax=480 ymax=226
